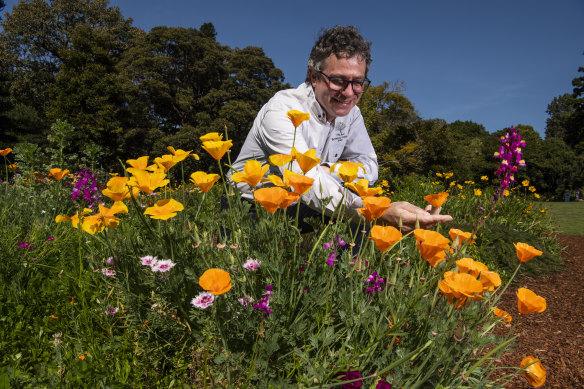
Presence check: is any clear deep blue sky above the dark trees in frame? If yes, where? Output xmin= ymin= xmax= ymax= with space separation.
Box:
xmin=5 ymin=0 xmax=584 ymax=137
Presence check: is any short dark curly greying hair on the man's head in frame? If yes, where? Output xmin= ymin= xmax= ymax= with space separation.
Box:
xmin=306 ymin=26 xmax=371 ymax=83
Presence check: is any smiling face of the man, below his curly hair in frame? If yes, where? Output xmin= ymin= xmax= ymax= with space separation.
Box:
xmin=310 ymin=54 xmax=367 ymax=121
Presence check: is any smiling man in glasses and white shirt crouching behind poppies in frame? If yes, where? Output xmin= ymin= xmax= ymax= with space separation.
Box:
xmin=228 ymin=26 xmax=452 ymax=232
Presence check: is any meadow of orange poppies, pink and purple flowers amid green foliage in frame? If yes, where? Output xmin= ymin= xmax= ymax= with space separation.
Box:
xmin=0 ymin=123 xmax=558 ymax=388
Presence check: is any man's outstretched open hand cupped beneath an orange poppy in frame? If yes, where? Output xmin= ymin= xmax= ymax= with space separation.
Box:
xmin=380 ymin=201 xmax=452 ymax=233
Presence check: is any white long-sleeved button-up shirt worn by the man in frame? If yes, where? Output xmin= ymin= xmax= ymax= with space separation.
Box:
xmin=229 ymin=83 xmax=378 ymax=219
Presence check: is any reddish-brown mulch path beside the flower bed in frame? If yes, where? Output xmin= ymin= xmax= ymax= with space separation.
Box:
xmin=498 ymin=235 xmax=584 ymax=388
